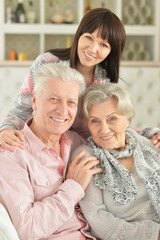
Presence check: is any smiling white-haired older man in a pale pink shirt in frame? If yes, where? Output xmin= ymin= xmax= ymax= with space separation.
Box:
xmin=0 ymin=64 xmax=102 ymax=240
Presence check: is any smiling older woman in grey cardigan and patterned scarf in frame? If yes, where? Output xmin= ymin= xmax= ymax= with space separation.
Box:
xmin=73 ymin=83 xmax=160 ymax=240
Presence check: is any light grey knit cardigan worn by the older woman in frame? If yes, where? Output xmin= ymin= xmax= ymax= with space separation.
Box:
xmin=72 ymin=131 xmax=160 ymax=240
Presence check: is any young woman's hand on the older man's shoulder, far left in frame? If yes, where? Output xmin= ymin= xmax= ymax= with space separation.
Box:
xmin=0 ymin=129 xmax=25 ymax=152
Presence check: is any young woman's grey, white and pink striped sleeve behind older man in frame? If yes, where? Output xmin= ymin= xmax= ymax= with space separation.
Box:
xmin=0 ymin=53 xmax=59 ymax=130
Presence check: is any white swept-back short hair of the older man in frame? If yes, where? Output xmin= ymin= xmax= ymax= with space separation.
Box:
xmin=34 ymin=63 xmax=86 ymax=97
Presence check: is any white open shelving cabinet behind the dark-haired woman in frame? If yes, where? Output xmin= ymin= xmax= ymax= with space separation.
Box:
xmin=0 ymin=0 xmax=160 ymax=62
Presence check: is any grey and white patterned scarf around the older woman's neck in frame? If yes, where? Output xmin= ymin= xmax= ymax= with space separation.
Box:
xmin=88 ymin=129 xmax=160 ymax=221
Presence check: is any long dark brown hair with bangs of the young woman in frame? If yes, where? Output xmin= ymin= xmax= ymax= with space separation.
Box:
xmin=49 ymin=8 xmax=126 ymax=83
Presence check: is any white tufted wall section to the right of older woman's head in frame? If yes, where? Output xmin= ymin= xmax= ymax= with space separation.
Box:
xmin=120 ymin=66 xmax=160 ymax=129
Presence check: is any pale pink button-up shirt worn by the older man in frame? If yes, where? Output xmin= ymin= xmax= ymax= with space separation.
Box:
xmin=0 ymin=121 xmax=95 ymax=240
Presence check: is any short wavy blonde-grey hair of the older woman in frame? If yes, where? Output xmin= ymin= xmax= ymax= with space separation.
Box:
xmin=81 ymin=83 xmax=135 ymax=123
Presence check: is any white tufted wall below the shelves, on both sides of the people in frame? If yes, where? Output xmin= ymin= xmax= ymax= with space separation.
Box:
xmin=0 ymin=66 xmax=160 ymax=129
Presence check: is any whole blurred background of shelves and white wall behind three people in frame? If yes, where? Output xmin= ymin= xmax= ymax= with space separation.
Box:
xmin=0 ymin=0 xmax=160 ymax=128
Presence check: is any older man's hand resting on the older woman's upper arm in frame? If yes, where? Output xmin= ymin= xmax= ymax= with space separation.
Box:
xmin=66 ymin=151 xmax=103 ymax=190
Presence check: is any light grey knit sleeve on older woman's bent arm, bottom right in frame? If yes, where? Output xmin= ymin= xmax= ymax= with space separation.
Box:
xmin=80 ymin=178 xmax=160 ymax=240
